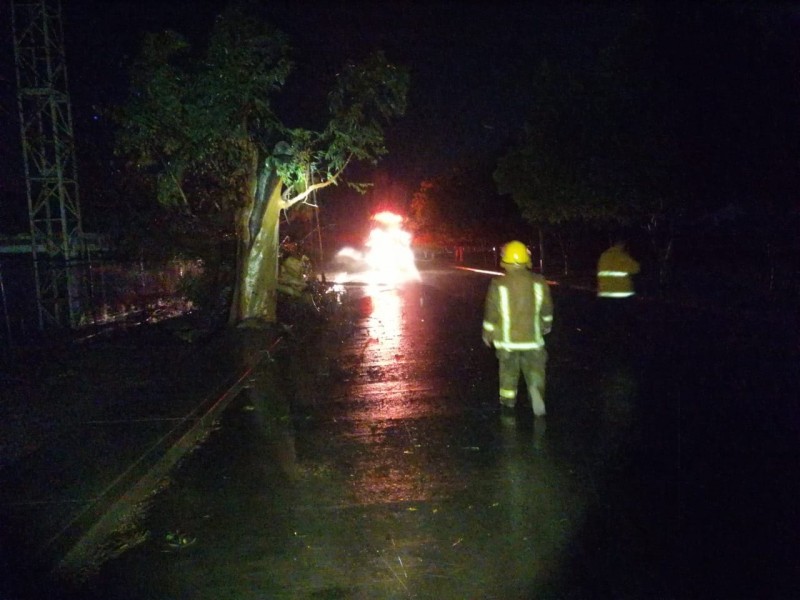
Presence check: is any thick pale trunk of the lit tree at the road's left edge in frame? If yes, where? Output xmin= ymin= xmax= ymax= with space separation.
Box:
xmin=229 ymin=171 xmax=283 ymax=324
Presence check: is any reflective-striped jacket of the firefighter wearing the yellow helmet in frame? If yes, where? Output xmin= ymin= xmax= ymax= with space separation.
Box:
xmin=483 ymin=268 xmax=553 ymax=350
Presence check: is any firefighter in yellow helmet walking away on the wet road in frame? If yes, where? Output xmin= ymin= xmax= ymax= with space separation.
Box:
xmin=483 ymin=240 xmax=553 ymax=417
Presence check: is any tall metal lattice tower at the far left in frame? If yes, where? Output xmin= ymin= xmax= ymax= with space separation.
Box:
xmin=11 ymin=0 xmax=84 ymax=328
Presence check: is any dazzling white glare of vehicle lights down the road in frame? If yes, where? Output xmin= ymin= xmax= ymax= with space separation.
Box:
xmin=335 ymin=211 xmax=420 ymax=287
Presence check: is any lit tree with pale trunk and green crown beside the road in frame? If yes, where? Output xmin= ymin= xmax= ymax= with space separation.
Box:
xmin=117 ymin=3 xmax=408 ymax=322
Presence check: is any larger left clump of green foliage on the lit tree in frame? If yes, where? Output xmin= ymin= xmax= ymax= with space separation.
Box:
xmin=115 ymin=5 xmax=292 ymax=218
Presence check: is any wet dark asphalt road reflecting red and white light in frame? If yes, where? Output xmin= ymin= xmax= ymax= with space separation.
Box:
xmin=76 ymin=271 xmax=800 ymax=600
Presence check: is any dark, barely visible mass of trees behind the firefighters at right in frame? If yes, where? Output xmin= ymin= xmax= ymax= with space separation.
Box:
xmin=494 ymin=3 xmax=800 ymax=298
